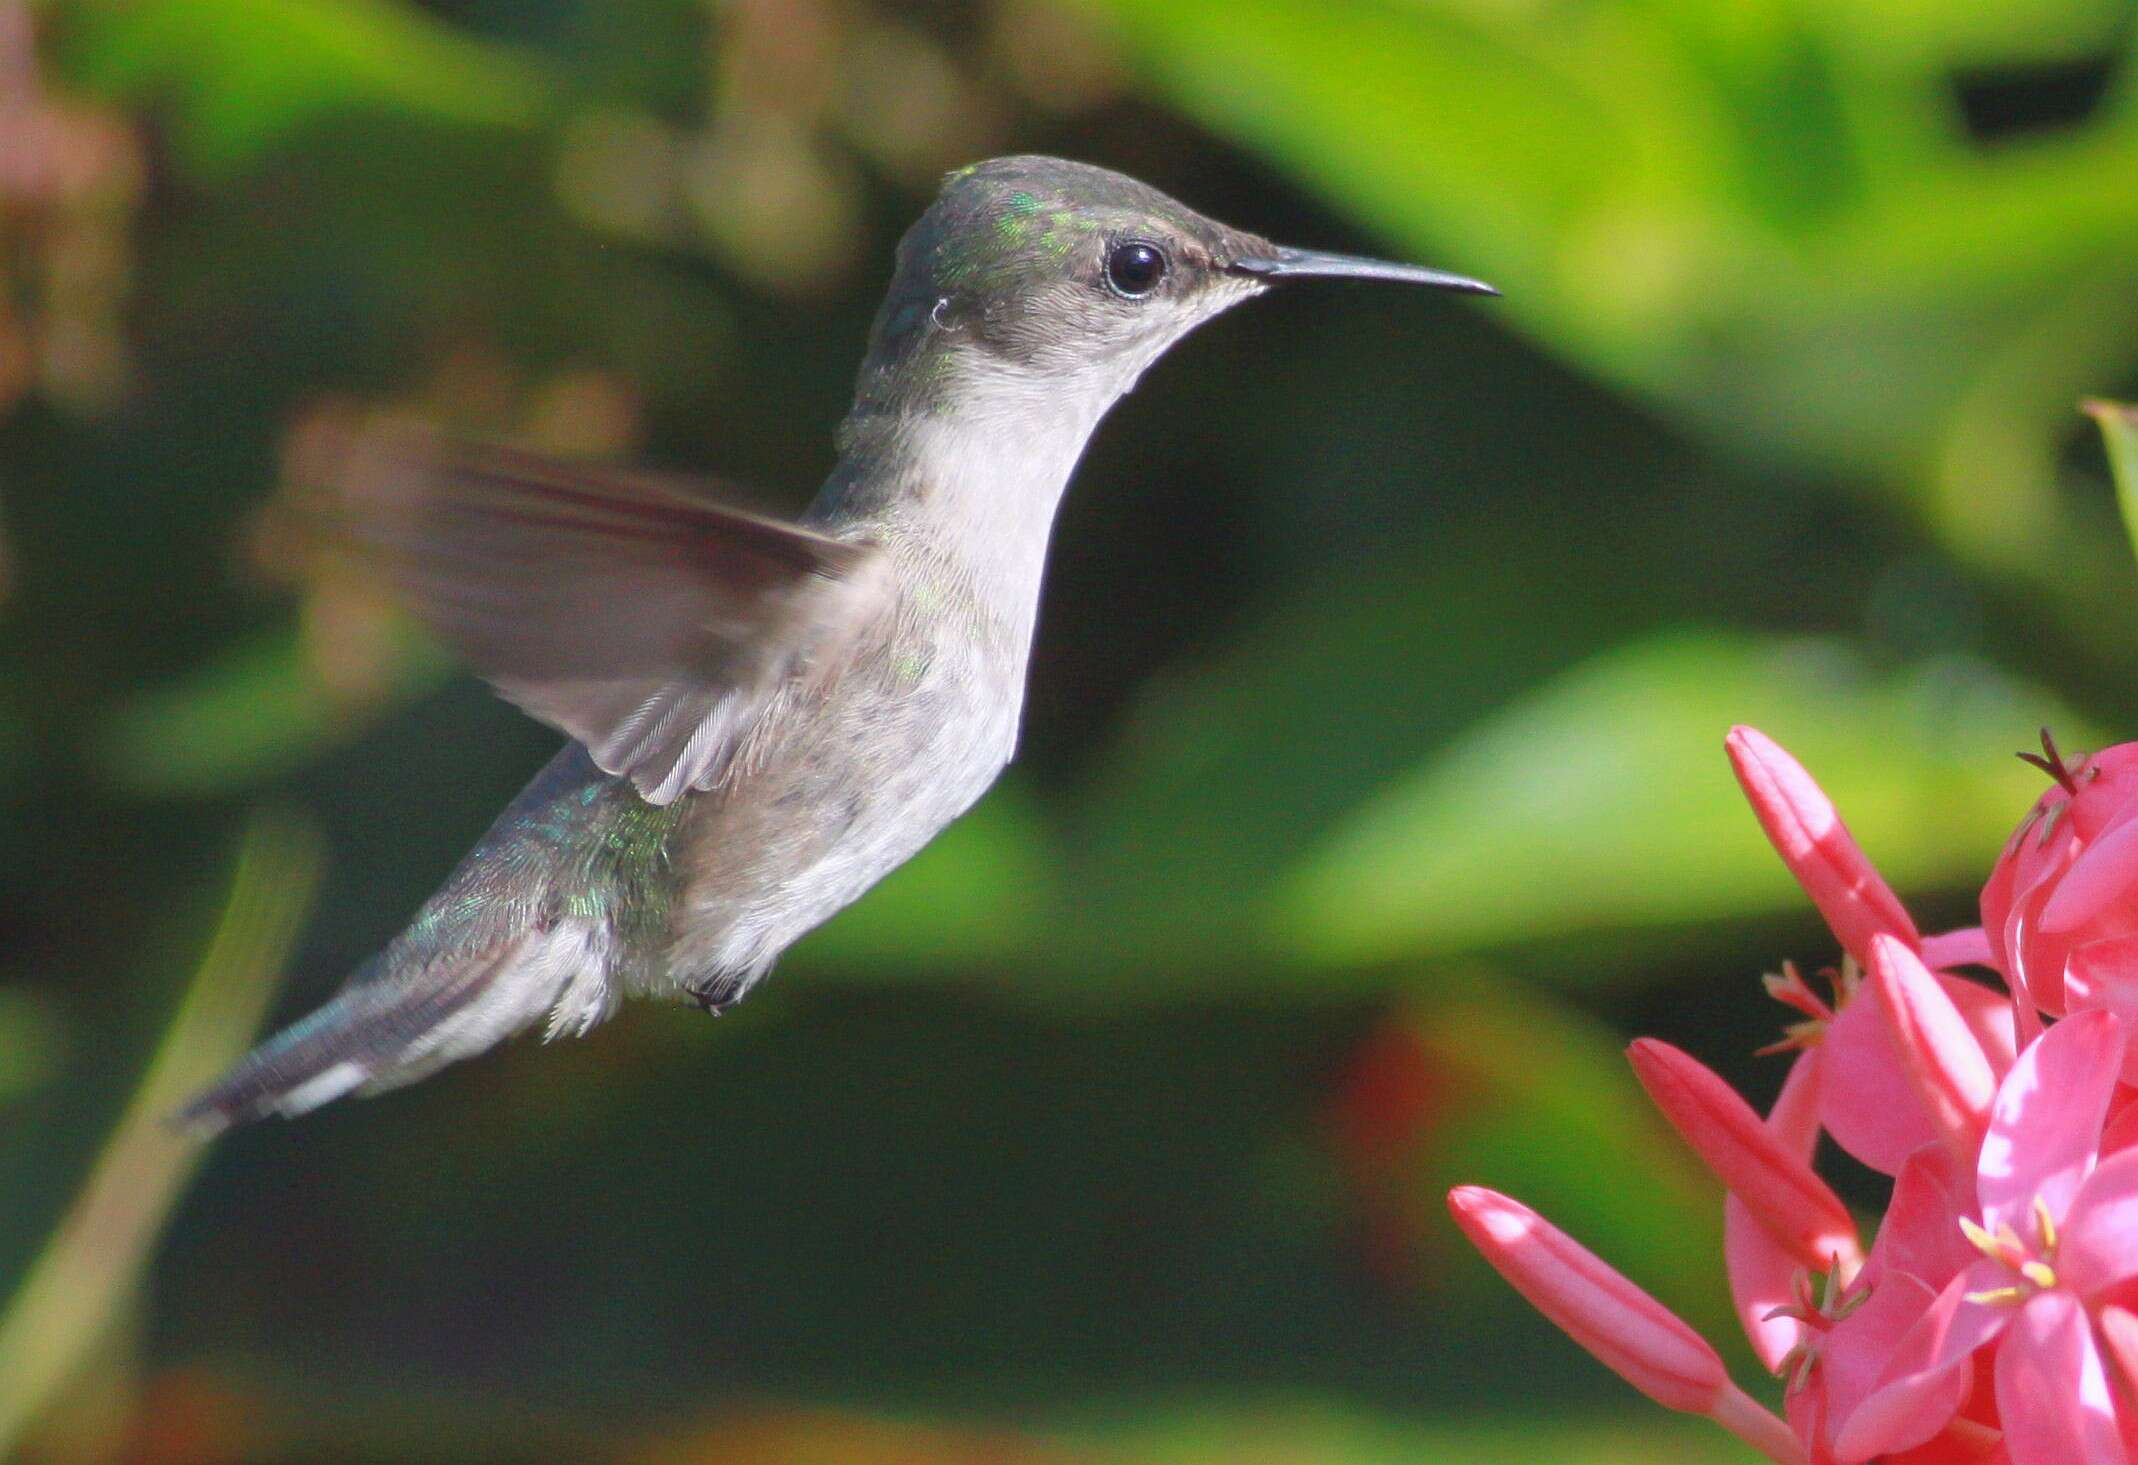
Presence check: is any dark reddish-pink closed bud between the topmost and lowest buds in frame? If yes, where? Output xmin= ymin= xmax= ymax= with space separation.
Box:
xmin=1627 ymin=1037 xmax=1862 ymax=1277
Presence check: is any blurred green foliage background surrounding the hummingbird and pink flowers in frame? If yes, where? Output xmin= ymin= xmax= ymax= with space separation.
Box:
xmin=0 ymin=0 xmax=2138 ymax=1465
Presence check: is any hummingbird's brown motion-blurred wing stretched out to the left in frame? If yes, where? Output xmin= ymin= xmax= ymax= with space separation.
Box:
xmin=322 ymin=432 xmax=885 ymax=804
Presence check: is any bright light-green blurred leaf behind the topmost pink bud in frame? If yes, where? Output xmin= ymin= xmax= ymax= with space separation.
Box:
xmin=1268 ymin=631 xmax=2091 ymax=962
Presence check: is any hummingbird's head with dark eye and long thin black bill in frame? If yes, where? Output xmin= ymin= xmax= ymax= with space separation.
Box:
xmin=842 ymin=156 xmax=1492 ymax=413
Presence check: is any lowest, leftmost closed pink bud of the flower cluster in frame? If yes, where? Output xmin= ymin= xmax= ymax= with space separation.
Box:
xmin=1447 ymin=1185 xmax=1730 ymax=1414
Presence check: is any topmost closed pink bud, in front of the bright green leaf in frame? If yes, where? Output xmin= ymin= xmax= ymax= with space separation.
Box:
xmin=1723 ymin=727 xmax=1918 ymax=960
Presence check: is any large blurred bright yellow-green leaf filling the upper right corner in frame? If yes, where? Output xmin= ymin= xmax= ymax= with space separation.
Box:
xmin=1088 ymin=0 xmax=2138 ymax=581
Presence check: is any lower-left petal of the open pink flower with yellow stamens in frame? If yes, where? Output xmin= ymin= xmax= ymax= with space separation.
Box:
xmin=1834 ymin=1262 xmax=2008 ymax=1465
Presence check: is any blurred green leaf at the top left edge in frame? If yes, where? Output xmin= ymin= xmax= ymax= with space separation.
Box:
xmin=66 ymin=0 xmax=545 ymax=173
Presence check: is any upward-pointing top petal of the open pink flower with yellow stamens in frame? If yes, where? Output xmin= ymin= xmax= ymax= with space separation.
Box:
xmin=1976 ymin=1012 xmax=2123 ymax=1236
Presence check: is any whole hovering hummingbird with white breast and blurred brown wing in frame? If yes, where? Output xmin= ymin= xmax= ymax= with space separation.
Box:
xmin=177 ymin=156 xmax=1497 ymax=1129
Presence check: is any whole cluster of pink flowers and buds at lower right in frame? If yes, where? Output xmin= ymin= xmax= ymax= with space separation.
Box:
xmin=1447 ymin=727 xmax=2138 ymax=1465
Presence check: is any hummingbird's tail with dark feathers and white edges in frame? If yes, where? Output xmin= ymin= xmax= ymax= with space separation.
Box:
xmin=171 ymin=922 xmax=616 ymax=1134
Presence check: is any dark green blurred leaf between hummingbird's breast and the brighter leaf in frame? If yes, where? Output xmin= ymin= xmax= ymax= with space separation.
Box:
xmin=1060 ymin=518 xmax=1641 ymax=986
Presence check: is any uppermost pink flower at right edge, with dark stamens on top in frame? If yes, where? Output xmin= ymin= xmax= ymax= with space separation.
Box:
xmin=1982 ymin=731 xmax=2138 ymax=1060
